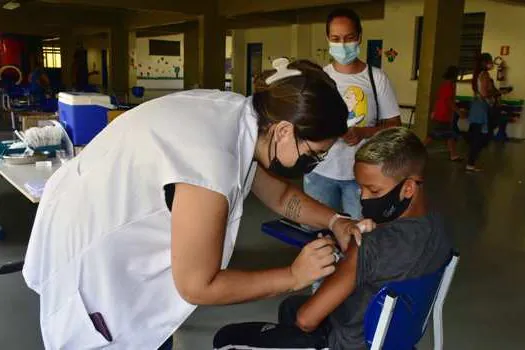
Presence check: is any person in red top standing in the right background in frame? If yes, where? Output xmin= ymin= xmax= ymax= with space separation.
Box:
xmin=425 ymin=66 xmax=463 ymax=162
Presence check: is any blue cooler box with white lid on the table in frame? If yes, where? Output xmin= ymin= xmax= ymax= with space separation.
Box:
xmin=58 ymin=92 xmax=113 ymax=146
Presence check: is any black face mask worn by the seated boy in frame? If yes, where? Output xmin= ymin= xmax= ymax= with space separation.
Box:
xmin=361 ymin=179 xmax=412 ymax=224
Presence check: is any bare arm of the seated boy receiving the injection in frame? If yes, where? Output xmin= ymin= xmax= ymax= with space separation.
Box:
xmin=296 ymin=243 xmax=358 ymax=332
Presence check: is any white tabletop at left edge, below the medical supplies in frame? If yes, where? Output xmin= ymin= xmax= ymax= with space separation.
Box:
xmin=0 ymin=160 xmax=61 ymax=203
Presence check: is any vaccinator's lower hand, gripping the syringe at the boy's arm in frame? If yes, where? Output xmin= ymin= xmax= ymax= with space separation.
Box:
xmin=290 ymin=237 xmax=335 ymax=291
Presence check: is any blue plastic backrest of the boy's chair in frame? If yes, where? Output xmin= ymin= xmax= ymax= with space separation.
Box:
xmin=364 ymin=255 xmax=457 ymax=350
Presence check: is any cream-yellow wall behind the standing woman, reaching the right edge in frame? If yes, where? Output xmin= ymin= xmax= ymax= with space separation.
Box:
xmin=229 ymin=0 xmax=525 ymax=137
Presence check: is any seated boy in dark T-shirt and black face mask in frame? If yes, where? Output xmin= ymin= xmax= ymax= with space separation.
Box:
xmin=214 ymin=128 xmax=452 ymax=350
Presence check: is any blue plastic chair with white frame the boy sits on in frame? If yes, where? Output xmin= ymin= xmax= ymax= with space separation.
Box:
xmin=364 ymin=253 xmax=459 ymax=350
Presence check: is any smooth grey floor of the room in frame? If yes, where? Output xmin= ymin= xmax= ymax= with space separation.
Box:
xmin=0 ymin=139 xmax=525 ymax=350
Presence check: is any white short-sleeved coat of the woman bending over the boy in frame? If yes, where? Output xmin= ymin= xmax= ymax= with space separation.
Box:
xmin=23 ymin=90 xmax=257 ymax=350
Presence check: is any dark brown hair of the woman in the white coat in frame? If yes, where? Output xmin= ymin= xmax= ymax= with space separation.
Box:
xmin=253 ymin=60 xmax=348 ymax=141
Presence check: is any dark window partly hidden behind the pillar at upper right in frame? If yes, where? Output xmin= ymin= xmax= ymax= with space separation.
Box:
xmin=412 ymin=12 xmax=485 ymax=80
